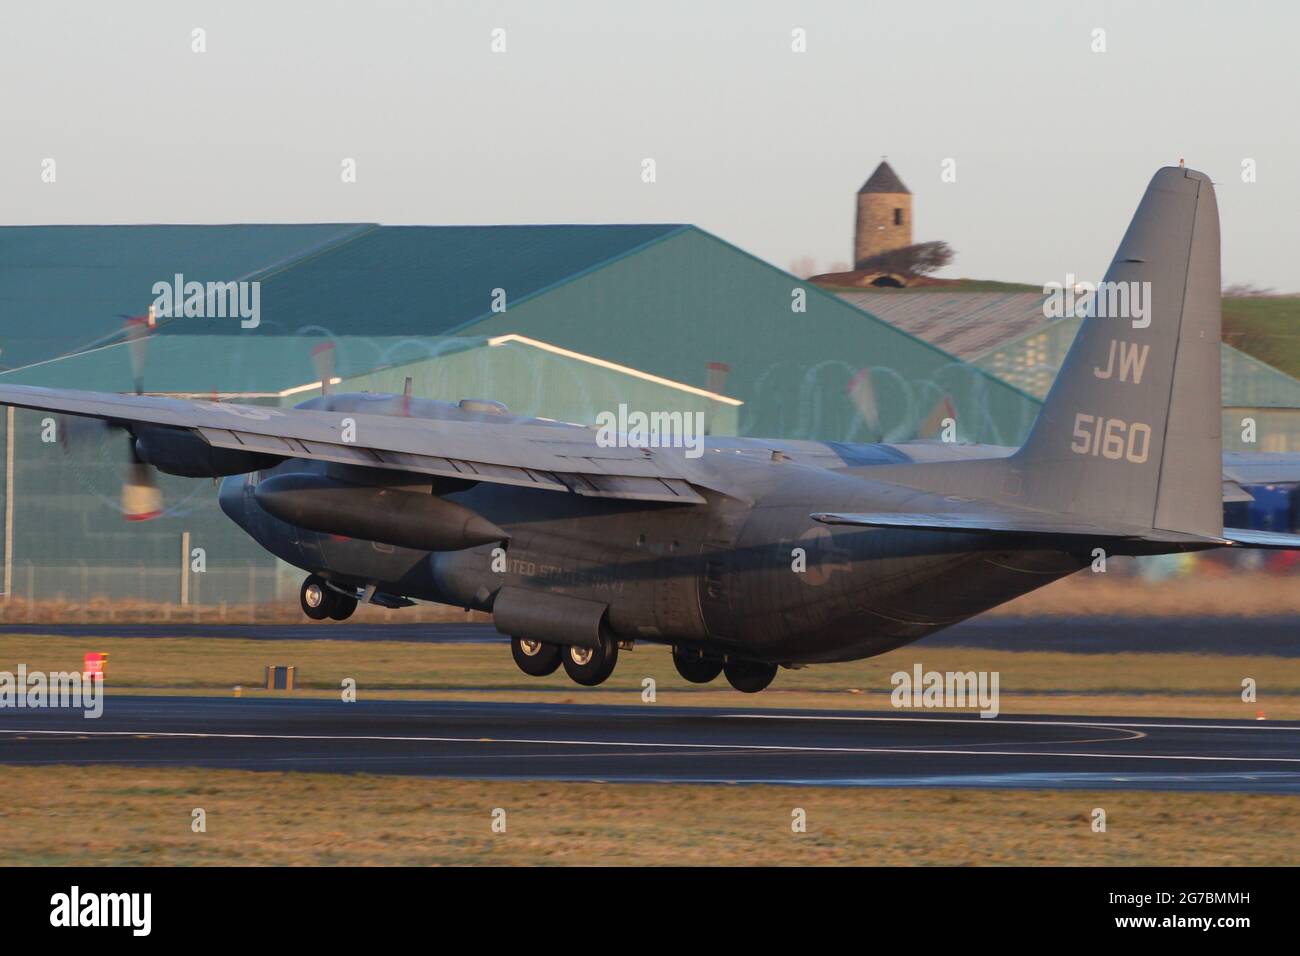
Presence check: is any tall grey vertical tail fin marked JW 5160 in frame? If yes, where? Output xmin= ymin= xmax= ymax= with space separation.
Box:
xmin=1000 ymin=166 xmax=1223 ymax=536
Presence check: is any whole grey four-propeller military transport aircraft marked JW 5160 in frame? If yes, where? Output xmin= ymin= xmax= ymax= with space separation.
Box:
xmin=0 ymin=160 xmax=1300 ymax=692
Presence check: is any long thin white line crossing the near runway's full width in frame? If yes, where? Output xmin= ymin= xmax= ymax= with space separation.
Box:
xmin=0 ymin=718 xmax=1300 ymax=763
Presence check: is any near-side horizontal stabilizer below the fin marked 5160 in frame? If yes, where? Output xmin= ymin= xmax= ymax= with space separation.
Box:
xmin=810 ymin=506 xmax=1227 ymax=546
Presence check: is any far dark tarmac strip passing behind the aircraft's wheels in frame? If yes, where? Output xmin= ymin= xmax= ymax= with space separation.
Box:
xmin=10 ymin=615 xmax=1300 ymax=657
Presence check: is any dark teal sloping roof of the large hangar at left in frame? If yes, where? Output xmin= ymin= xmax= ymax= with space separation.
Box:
xmin=0 ymin=224 xmax=684 ymax=368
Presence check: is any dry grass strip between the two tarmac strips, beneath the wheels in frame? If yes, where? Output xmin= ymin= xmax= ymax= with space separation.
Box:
xmin=0 ymin=635 xmax=1300 ymax=719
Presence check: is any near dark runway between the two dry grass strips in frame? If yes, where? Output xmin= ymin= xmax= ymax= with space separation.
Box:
xmin=0 ymin=696 xmax=1300 ymax=793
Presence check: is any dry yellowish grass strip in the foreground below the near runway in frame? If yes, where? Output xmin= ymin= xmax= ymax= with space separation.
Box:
xmin=0 ymin=767 xmax=1300 ymax=866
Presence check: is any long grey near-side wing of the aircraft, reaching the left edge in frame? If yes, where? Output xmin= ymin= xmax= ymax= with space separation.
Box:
xmin=0 ymin=385 xmax=715 ymax=503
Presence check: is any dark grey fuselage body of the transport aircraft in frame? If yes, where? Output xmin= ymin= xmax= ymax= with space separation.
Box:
xmin=221 ymin=441 xmax=1088 ymax=663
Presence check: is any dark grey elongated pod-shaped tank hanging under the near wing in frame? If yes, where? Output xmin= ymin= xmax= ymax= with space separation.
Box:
xmin=254 ymin=473 xmax=510 ymax=551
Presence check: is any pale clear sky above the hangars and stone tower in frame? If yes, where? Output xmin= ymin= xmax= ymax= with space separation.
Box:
xmin=0 ymin=0 xmax=1300 ymax=291
